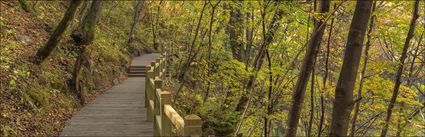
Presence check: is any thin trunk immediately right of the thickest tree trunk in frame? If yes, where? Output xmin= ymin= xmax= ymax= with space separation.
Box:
xmin=350 ymin=1 xmax=376 ymax=137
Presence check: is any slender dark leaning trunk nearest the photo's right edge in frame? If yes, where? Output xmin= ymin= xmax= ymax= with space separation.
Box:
xmin=381 ymin=0 xmax=419 ymax=137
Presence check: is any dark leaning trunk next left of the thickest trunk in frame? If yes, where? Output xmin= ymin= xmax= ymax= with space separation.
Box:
xmin=286 ymin=0 xmax=330 ymax=137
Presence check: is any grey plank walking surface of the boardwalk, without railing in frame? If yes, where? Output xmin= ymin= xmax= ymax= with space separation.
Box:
xmin=60 ymin=54 xmax=160 ymax=136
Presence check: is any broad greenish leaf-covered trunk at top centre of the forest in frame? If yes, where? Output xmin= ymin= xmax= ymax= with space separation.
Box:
xmin=227 ymin=0 xmax=244 ymax=62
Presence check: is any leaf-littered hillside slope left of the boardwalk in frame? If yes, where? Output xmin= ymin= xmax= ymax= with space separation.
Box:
xmin=0 ymin=1 xmax=144 ymax=136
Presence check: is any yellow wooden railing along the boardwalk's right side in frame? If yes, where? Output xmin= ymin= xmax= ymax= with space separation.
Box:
xmin=145 ymin=55 xmax=202 ymax=136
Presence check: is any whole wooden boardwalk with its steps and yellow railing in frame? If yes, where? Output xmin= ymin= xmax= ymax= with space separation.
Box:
xmin=59 ymin=54 xmax=202 ymax=137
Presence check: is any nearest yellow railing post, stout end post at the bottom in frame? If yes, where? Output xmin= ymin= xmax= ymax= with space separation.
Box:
xmin=183 ymin=115 xmax=202 ymax=136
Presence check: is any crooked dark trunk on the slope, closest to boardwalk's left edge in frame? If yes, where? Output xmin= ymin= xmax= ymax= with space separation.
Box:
xmin=71 ymin=0 xmax=102 ymax=104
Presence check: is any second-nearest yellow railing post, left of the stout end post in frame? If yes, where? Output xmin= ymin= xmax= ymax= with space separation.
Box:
xmin=161 ymin=91 xmax=173 ymax=136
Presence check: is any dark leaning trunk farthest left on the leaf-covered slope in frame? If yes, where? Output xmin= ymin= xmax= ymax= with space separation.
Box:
xmin=36 ymin=0 xmax=82 ymax=64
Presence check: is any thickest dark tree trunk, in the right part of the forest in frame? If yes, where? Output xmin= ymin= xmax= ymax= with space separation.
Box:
xmin=330 ymin=1 xmax=373 ymax=136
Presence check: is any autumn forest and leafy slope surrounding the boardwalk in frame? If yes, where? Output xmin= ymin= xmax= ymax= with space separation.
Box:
xmin=0 ymin=0 xmax=425 ymax=136
